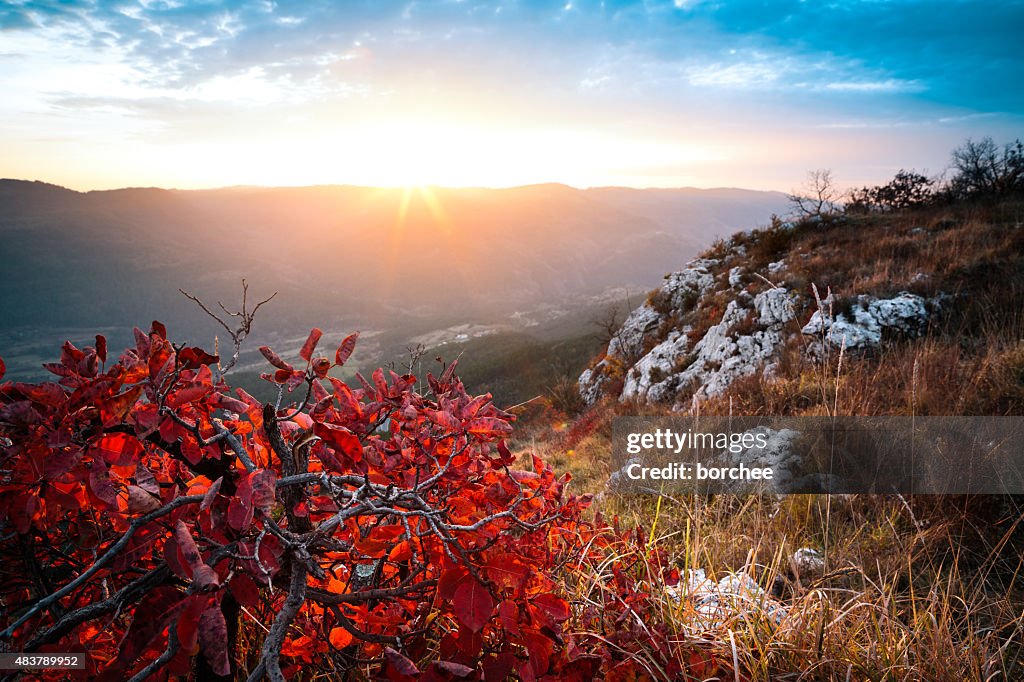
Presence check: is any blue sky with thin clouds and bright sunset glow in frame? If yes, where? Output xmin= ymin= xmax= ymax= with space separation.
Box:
xmin=0 ymin=0 xmax=1024 ymax=191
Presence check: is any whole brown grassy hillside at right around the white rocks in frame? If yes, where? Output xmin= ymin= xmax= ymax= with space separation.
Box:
xmin=519 ymin=199 xmax=1024 ymax=680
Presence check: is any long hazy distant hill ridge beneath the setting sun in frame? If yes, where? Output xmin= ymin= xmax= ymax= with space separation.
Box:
xmin=0 ymin=180 xmax=786 ymax=382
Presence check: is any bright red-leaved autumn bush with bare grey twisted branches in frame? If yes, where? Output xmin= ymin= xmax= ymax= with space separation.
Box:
xmin=0 ymin=323 xmax=604 ymax=680
